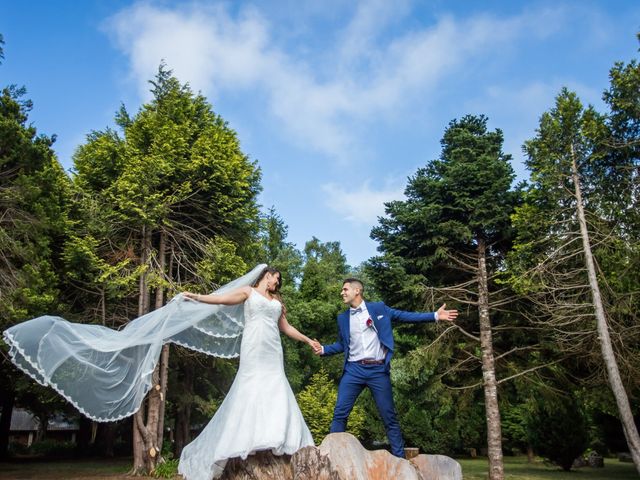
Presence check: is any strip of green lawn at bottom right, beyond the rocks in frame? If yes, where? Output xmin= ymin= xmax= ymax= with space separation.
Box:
xmin=457 ymin=457 xmax=638 ymax=480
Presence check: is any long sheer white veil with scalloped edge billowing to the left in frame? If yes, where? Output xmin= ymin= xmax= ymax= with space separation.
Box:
xmin=3 ymin=265 xmax=266 ymax=422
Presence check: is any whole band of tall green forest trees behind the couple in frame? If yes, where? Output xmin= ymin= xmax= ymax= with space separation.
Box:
xmin=0 ymin=24 xmax=640 ymax=478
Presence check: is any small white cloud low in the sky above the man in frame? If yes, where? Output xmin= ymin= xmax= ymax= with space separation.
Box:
xmin=322 ymin=182 xmax=404 ymax=225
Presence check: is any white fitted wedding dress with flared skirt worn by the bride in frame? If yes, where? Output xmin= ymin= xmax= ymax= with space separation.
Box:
xmin=178 ymin=288 xmax=314 ymax=480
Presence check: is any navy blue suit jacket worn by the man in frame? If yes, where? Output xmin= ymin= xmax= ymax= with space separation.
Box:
xmin=323 ymin=301 xmax=436 ymax=371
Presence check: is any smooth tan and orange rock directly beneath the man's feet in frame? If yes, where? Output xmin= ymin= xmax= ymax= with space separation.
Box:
xmin=320 ymin=433 xmax=423 ymax=480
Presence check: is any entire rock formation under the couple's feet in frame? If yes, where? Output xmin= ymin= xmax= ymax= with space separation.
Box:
xmin=221 ymin=433 xmax=462 ymax=480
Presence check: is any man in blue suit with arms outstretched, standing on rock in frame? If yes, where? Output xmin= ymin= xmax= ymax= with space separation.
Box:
xmin=313 ymin=278 xmax=458 ymax=458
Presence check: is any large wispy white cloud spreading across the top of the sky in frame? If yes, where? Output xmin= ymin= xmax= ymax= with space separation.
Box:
xmin=105 ymin=1 xmax=563 ymax=161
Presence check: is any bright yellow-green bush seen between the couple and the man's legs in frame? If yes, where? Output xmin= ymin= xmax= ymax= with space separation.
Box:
xmin=297 ymin=369 xmax=365 ymax=445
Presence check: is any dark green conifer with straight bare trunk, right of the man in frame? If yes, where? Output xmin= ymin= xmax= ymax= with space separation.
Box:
xmin=370 ymin=116 xmax=518 ymax=479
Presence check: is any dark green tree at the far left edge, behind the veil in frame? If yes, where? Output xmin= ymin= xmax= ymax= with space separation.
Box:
xmin=0 ymin=82 xmax=70 ymax=456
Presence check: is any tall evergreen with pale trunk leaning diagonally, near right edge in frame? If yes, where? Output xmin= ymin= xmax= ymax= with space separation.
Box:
xmin=511 ymin=89 xmax=640 ymax=471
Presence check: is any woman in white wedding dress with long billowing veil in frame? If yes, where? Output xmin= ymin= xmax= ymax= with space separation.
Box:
xmin=3 ymin=264 xmax=316 ymax=480
